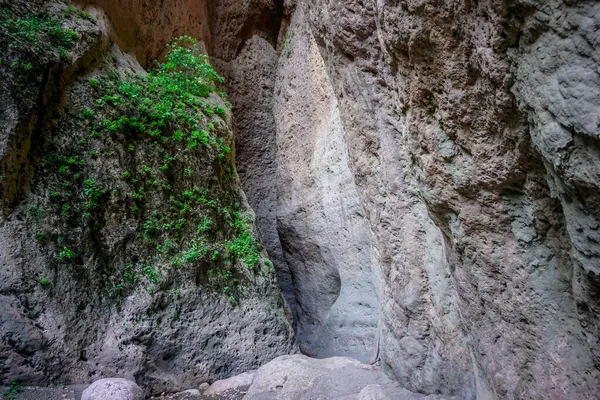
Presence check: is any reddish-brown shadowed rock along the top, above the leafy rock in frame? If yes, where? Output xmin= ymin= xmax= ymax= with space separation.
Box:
xmin=83 ymin=0 xmax=282 ymax=66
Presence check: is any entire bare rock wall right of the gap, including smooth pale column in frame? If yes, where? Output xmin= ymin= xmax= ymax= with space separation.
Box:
xmin=258 ymin=0 xmax=600 ymax=399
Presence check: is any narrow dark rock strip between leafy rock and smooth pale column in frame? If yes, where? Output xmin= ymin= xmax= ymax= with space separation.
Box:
xmin=216 ymin=36 xmax=297 ymax=320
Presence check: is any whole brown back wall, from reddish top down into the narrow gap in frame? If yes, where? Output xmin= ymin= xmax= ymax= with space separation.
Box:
xmin=85 ymin=0 xmax=296 ymax=318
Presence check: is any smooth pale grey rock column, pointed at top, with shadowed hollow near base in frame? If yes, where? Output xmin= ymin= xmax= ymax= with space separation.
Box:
xmin=274 ymin=9 xmax=379 ymax=361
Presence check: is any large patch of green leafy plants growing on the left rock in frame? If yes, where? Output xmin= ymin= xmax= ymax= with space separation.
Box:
xmin=32 ymin=37 xmax=262 ymax=300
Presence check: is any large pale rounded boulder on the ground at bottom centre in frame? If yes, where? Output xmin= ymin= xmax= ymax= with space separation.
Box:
xmin=244 ymin=355 xmax=458 ymax=400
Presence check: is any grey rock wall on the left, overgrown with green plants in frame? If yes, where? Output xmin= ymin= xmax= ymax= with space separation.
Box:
xmin=0 ymin=1 xmax=295 ymax=394
